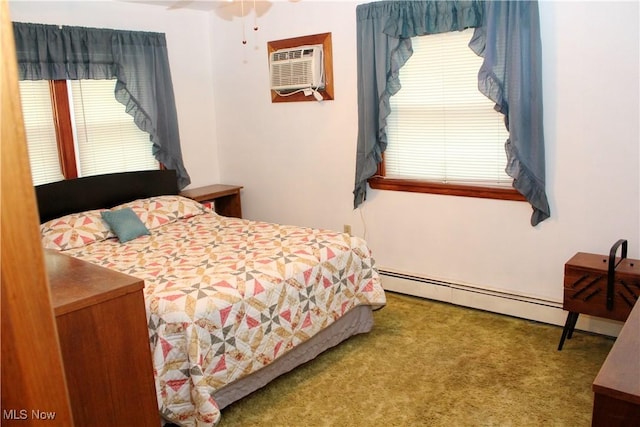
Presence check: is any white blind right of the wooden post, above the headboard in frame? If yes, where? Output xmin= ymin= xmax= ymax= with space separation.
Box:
xmin=68 ymin=80 xmax=159 ymax=176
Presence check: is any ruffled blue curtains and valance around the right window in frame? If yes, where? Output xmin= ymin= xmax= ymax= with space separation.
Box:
xmin=354 ymin=0 xmax=550 ymax=225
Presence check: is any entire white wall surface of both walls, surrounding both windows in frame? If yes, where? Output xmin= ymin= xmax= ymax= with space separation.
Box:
xmin=10 ymin=0 xmax=640 ymax=318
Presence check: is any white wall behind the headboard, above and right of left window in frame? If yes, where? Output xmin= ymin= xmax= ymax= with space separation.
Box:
xmin=9 ymin=0 xmax=220 ymax=187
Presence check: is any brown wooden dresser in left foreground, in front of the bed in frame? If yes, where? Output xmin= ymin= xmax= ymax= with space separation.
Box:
xmin=45 ymin=250 xmax=160 ymax=427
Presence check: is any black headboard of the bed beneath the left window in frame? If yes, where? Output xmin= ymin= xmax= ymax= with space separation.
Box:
xmin=35 ymin=170 xmax=179 ymax=223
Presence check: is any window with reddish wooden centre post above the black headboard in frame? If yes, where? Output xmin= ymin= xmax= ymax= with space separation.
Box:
xmin=20 ymin=80 xmax=159 ymax=185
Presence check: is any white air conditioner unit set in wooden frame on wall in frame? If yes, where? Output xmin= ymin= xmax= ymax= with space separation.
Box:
xmin=269 ymin=44 xmax=324 ymax=91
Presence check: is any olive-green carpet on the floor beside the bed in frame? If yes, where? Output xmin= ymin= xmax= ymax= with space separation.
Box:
xmin=220 ymin=293 xmax=614 ymax=427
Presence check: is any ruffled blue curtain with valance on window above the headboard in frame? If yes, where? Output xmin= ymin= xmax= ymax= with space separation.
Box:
xmin=13 ymin=22 xmax=191 ymax=189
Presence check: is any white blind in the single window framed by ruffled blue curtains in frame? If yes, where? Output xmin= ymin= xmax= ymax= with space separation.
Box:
xmin=385 ymin=29 xmax=512 ymax=186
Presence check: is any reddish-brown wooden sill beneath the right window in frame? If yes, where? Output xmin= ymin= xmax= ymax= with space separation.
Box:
xmin=368 ymin=176 xmax=526 ymax=202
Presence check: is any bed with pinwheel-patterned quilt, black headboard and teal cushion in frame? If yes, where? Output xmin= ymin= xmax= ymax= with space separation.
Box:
xmin=36 ymin=171 xmax=386 ymax=426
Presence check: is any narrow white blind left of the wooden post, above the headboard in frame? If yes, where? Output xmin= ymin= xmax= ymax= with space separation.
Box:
xmin=20 ymin=80 xmax=64 ymax=185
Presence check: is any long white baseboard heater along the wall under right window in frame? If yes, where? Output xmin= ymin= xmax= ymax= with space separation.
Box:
xmin=378 ymin=268 xmax=621 ymax=336
